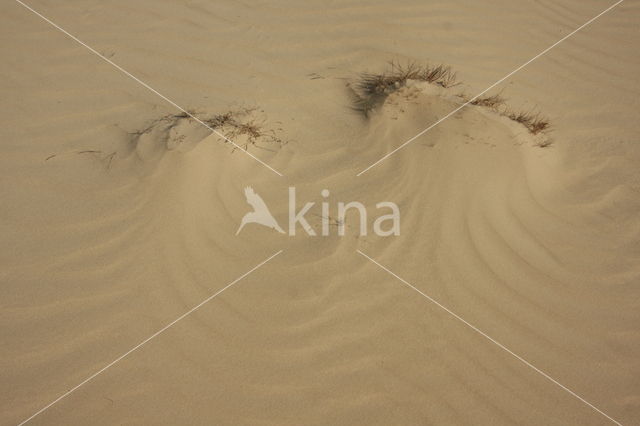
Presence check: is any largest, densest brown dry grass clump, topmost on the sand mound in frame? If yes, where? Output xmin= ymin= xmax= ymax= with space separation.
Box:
xmin=349 ymin=62 xmax=458 ymax=117
